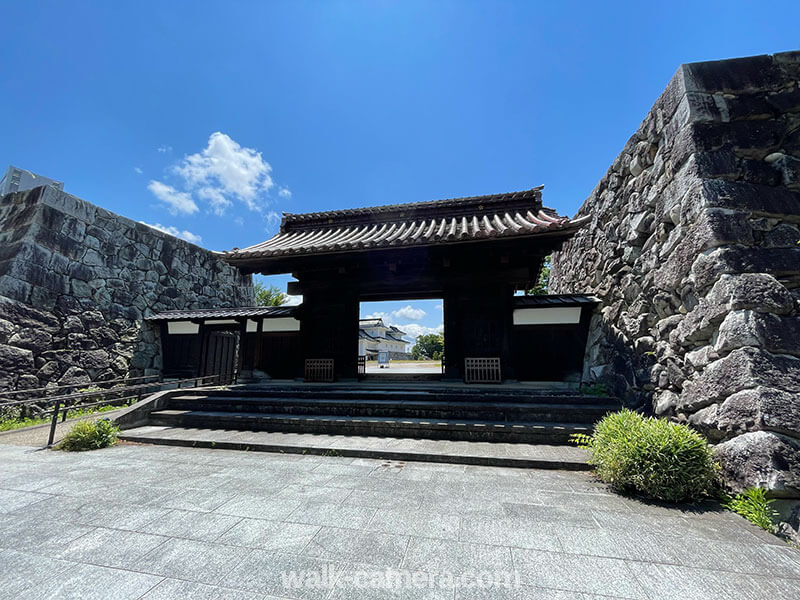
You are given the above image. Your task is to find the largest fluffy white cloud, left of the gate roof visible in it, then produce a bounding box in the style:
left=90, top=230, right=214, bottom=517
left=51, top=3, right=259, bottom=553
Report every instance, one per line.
left=174, top=131, right=275, bottom=214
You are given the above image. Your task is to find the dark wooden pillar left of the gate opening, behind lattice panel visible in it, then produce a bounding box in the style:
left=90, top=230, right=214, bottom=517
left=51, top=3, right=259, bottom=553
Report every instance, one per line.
left=300, top=285, right=358, bottom=380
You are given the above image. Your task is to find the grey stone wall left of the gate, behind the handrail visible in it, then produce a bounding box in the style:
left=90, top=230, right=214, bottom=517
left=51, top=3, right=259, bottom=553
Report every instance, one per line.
left=0, top=187, right=254, bottom=390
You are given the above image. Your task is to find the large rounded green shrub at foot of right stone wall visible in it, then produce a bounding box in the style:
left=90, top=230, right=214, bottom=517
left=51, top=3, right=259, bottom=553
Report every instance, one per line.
left=573, top=409, right=719, bottom=502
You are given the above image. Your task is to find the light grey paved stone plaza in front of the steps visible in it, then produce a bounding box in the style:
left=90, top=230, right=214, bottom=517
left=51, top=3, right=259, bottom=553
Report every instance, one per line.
left=0, top=445, right=800, bottom=600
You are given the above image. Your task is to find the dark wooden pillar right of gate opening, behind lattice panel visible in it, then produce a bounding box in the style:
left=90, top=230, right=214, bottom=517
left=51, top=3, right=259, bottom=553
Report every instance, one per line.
left=444, top=284, right=516, bottom=380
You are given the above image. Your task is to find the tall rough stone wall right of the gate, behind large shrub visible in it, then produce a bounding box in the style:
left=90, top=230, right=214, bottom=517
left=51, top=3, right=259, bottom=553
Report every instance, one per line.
left=552, top=52, right=800, bottom=529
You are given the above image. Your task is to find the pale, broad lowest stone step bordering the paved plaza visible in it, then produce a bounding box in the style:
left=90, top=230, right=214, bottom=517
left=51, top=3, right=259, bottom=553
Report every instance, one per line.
left=121, top=425, right=589, bottom=471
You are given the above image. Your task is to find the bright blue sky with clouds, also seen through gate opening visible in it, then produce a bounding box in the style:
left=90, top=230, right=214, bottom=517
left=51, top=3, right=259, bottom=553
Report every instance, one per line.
left=0, top=0, right=800, bottom=342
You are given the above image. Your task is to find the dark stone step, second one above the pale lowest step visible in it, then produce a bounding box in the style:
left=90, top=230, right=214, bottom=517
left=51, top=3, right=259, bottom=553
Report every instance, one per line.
left=161, top=396, right=619, bottom=424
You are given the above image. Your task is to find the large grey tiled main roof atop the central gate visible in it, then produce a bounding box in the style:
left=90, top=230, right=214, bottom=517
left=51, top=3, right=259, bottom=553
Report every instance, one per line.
left=225, top=188, right=590, bottom=263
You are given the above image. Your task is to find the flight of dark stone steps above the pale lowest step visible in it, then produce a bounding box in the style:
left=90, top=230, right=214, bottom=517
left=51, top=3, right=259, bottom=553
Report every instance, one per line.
left=123, top=383, right=620, bottom=445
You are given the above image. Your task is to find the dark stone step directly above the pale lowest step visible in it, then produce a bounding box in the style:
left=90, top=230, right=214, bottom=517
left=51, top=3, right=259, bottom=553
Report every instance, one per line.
left=150, top=409, right=592, bottom=444
